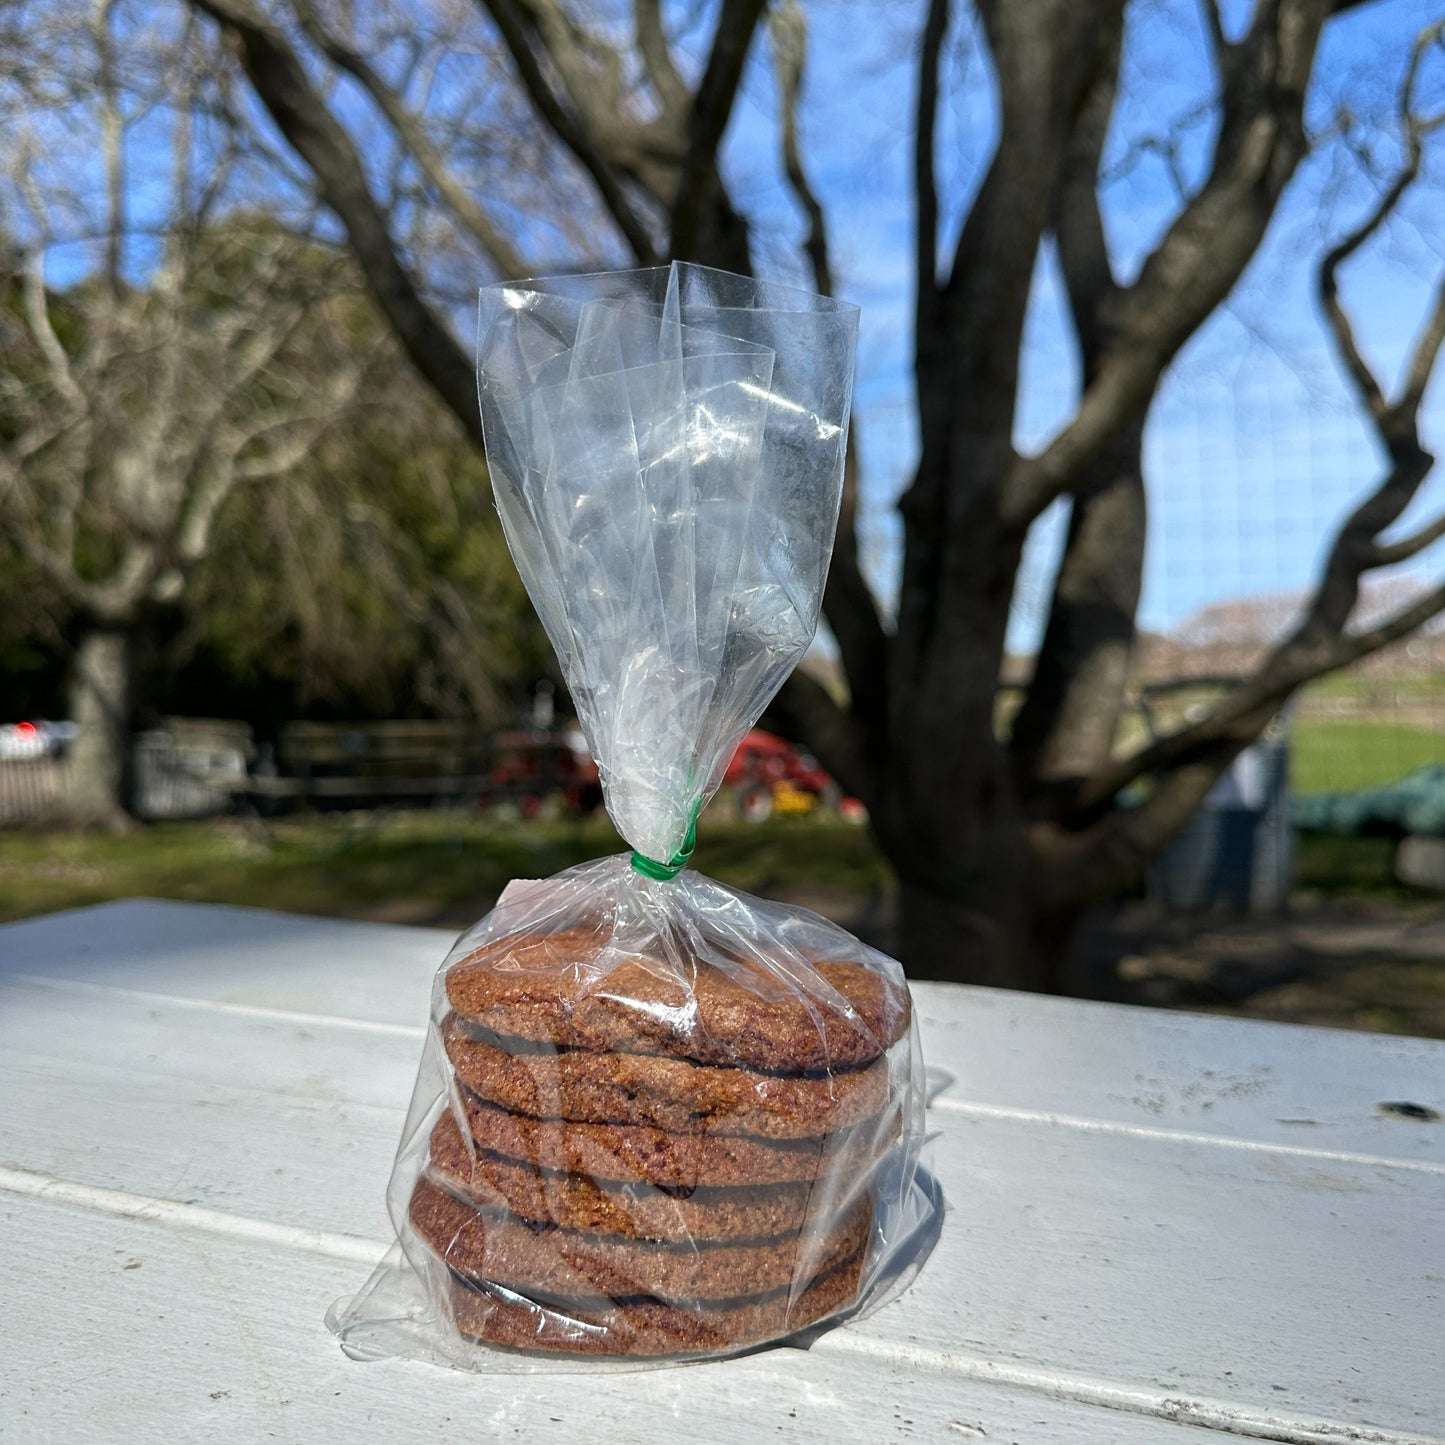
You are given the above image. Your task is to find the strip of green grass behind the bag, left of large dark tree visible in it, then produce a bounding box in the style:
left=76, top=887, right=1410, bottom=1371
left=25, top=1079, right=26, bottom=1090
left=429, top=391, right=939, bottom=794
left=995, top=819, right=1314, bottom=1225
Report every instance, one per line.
left=0, top=812, right=887, bottom=922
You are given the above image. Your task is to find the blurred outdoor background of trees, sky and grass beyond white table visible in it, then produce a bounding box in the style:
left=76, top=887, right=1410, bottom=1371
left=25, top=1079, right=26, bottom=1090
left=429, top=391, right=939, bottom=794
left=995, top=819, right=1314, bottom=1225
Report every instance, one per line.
left=0, top=0, right=1445, bottom=1036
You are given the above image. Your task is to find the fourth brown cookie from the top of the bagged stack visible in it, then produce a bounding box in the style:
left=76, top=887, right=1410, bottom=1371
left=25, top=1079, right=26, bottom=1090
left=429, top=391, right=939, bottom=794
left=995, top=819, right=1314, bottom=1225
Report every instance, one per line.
left=428, top=1114, right=826, bottom=1244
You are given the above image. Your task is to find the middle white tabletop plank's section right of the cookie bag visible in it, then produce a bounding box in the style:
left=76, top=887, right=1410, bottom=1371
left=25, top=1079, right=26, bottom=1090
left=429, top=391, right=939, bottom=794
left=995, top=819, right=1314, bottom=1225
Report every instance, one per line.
left=843, top=1116, right=1445, bottom=1439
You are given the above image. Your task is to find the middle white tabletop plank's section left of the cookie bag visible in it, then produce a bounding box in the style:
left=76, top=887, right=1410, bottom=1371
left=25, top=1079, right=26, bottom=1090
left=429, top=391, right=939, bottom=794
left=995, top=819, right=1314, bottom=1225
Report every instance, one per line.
left=0, top=981, right=407, bottom=1242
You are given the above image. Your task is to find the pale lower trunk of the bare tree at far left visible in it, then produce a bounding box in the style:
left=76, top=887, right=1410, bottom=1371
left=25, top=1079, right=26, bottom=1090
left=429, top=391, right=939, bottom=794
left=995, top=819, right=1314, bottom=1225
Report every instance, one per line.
left=65, top=627, right=131, bottom=828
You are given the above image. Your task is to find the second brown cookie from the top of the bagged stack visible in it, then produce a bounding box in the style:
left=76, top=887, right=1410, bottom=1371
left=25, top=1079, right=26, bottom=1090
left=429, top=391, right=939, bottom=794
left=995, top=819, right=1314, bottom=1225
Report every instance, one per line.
left=441, top=1014, right=889, bottom=1139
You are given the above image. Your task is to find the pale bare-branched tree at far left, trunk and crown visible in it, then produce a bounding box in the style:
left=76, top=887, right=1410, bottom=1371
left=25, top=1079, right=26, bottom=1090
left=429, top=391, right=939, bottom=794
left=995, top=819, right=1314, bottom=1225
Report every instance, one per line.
left=0, top=0, right=381, bottom=827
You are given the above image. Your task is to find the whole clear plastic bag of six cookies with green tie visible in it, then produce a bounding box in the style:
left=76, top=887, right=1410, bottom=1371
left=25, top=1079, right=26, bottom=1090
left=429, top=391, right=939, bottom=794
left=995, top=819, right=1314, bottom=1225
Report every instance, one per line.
left=328, top=264, right=939, bottom=1370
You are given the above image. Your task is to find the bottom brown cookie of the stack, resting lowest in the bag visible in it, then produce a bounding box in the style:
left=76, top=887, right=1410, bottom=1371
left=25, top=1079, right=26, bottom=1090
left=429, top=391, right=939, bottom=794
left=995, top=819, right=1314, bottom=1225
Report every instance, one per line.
left=451, top=1253, right=863, bottom=1355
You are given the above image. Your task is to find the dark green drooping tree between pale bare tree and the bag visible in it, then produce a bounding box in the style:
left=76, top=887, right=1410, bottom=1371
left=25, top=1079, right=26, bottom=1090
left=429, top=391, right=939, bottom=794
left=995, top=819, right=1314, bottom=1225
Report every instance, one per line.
left=170, top=359, right=556, bottom=731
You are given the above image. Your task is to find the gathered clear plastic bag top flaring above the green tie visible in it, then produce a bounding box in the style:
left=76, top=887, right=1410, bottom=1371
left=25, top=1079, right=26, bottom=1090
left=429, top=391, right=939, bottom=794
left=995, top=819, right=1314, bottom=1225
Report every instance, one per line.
left=478, top=264, right=857, bottom=881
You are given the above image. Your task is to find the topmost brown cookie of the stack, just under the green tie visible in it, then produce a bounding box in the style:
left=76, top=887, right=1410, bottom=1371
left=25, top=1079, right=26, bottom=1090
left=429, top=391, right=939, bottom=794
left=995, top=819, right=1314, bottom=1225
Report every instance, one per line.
left=445, top=928, right=909, bottom=1074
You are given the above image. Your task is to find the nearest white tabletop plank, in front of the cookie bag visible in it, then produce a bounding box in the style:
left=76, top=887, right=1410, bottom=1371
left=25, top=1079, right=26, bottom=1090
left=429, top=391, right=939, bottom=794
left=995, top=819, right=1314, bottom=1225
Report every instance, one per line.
left=0, top=1192, right=1254, bottom=1445
